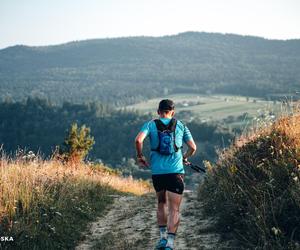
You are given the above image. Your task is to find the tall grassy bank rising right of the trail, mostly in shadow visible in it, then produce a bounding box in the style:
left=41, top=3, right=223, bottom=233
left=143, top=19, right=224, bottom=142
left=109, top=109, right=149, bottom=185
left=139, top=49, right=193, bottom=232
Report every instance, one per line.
left=199, top=114, right=300, bottom=249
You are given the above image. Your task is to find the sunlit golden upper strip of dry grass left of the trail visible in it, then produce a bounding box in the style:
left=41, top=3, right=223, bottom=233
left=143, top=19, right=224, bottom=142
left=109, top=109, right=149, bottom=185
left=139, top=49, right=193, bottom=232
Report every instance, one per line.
left=0, top=158, right=150, bottom=222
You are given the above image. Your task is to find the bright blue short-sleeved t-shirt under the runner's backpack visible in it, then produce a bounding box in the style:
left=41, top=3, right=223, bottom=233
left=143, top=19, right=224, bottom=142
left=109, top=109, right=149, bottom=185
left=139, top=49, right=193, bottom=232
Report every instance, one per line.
left=141, top=118, right=193, bottom=175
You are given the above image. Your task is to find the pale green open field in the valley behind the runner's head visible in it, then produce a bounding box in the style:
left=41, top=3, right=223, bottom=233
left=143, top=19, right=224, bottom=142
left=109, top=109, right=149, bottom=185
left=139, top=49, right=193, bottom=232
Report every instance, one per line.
left=126, top=94, right=282, bottom=129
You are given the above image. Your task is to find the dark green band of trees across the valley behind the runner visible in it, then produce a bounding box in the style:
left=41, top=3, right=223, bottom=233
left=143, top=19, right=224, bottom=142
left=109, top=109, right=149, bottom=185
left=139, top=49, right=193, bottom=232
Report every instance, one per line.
left=0, top=98, right=233, bottom=170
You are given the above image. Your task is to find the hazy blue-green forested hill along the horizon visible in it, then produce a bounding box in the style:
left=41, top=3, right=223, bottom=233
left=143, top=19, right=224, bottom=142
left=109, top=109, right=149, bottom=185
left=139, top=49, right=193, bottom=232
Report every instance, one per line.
left=0, top=32, right=300, bottom=105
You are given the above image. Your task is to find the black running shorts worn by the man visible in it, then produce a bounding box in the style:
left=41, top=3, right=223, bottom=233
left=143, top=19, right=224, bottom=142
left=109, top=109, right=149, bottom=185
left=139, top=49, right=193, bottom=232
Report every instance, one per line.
left=152, top=174, right=184, bottom=194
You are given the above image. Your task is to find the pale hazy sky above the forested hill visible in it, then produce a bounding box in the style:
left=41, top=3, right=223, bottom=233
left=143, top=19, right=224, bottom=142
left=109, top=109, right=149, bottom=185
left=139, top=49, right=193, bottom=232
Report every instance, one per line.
left=0, top=0, right=300, bottom=48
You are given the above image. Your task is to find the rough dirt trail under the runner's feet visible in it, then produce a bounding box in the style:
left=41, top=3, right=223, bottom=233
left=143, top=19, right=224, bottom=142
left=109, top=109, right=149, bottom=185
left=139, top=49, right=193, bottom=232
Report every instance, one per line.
left=76, top=192, right=220, bottom=250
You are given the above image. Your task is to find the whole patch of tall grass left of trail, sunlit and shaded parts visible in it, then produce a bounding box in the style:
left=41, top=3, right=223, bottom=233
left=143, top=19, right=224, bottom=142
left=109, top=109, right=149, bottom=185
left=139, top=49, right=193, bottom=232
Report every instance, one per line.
left=0, top=156, right=149, bottom=249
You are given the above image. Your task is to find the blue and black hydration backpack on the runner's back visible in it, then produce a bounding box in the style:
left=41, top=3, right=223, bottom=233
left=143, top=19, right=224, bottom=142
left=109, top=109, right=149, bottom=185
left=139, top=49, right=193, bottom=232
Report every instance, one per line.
left=154, top=118, right=178, bottom=155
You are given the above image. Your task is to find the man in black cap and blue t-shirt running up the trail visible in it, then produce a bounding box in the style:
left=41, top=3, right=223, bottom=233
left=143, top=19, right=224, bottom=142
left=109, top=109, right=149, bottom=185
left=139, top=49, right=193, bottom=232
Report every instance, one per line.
left=135, top=99, right=196, bottom=250
